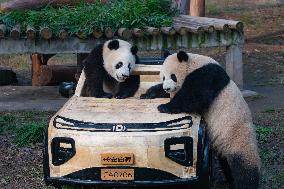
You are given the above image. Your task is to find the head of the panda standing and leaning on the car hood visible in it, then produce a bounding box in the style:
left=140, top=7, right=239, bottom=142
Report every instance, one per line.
left=160, top=51, right=189, bottom=93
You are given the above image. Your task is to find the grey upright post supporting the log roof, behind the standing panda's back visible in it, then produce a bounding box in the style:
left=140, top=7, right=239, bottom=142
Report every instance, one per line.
left=226, top=45, right=243, bottom=89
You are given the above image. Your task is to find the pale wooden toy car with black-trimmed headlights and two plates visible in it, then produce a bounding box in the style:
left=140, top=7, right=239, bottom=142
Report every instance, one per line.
left=44, top=59, right=210, bottom=188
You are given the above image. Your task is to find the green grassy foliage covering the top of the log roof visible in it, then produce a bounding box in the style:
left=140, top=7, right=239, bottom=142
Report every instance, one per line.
left=0, top=0, right=177, bottom=35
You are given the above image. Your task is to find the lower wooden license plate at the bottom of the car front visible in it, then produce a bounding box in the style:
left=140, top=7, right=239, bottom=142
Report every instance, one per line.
left=101, top=169, right=134, bottom=181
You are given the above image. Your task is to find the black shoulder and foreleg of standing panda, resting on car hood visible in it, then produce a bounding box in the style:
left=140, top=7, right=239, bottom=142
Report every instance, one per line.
left=159, top=64, right=230, bottom=115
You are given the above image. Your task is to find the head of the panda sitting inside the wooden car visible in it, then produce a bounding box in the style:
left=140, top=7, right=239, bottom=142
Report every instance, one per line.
left=103, top=39, right=138, bottom=82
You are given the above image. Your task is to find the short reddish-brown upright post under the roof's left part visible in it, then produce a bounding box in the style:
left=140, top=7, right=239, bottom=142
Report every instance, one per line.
left=31, top=54, right=43, bottom=86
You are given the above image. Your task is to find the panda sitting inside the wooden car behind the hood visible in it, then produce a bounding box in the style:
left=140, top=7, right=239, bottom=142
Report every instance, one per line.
left=83, top=39, right=140, bottom=98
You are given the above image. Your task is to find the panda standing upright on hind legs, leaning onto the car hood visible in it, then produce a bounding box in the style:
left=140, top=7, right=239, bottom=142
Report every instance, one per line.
left=142, top=51, right=260, bottom=189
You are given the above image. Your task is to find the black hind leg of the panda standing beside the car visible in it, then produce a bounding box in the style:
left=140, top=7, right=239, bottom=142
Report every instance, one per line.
left=219, top=155, right=260, bottom=189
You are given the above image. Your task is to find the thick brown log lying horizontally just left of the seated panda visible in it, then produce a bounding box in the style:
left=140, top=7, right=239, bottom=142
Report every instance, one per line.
left=39, top=65, right=77, bottom=86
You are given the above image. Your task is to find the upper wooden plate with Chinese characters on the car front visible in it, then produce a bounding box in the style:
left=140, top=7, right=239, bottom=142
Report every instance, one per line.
left=101, top=153, right=134, bottom=165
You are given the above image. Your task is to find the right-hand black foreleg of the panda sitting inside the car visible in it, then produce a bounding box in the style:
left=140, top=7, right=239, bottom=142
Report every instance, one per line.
left=115, top=75, right=140, bottom=99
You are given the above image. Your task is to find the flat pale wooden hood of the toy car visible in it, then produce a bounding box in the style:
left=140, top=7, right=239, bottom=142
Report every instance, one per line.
left=59, top=97, right=191, bottom=123
